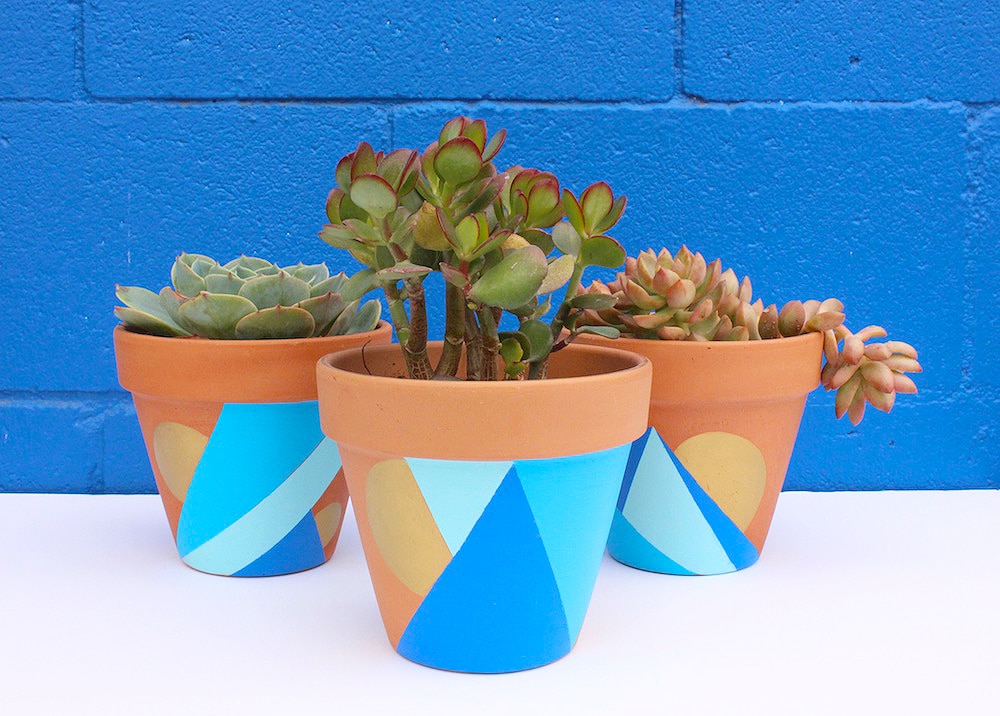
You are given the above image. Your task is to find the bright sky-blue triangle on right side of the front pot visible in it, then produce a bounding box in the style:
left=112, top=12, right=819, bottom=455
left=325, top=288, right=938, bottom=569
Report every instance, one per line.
left=514, top=445, right=630, bottom=643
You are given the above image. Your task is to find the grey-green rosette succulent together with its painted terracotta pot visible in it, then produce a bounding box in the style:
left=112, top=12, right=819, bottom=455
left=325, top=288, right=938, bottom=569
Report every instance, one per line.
left=114, top=253, right=391, bottom=576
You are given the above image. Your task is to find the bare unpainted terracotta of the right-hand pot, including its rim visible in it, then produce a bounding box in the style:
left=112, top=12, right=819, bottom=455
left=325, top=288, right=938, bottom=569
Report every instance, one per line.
left=578, top=333, right=823, bottom=550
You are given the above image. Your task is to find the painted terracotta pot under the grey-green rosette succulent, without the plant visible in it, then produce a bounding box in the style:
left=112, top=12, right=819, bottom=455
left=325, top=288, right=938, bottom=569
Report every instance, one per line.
left=114, top=322, right=392, bottom=577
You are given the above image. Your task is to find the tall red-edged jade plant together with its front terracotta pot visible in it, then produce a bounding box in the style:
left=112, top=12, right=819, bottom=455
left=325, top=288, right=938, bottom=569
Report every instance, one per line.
left=317, top=117, right=651, bottom=672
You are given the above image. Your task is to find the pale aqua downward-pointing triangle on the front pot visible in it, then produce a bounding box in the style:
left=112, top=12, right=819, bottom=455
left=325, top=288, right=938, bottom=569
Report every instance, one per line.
left=406, top=457, right=514, bottom=554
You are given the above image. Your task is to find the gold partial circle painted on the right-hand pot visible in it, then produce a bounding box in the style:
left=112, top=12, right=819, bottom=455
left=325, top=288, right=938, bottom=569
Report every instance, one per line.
left=674, top=432, right=767, bottom=531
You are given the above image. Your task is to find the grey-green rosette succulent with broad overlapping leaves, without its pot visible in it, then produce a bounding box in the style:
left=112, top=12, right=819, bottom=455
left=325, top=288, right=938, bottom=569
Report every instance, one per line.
left=115, top=253, right=381, bottom=340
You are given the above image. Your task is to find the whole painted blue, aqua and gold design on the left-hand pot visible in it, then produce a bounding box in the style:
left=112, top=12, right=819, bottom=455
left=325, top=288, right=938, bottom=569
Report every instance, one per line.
left=152, top=401, right=347, bottom=577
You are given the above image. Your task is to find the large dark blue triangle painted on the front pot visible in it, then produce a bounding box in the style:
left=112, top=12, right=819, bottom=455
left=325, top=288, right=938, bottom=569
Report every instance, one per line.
left=396, top=468, right=571, bottom=673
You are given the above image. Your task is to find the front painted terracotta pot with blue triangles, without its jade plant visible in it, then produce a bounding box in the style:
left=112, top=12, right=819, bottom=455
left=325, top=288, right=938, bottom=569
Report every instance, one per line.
left=317, top=345, right=651, bottom=673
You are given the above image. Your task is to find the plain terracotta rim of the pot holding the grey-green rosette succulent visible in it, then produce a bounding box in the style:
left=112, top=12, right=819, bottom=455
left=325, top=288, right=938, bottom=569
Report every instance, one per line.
left=114, top=321, right=392, bottom=403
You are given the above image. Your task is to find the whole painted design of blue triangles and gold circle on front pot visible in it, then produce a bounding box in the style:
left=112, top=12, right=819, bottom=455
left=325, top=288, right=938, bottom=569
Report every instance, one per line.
left=364, top=445, right=629, bottom=673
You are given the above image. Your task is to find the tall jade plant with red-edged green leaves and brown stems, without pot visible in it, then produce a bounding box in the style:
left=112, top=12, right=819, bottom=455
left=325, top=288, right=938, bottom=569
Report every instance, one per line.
left=320, top=117, right=626, bottom=380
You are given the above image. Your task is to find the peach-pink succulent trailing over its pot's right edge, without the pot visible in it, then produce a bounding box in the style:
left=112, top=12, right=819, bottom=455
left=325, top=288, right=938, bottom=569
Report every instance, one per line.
left=578, top=246, right=921, bottom=425
